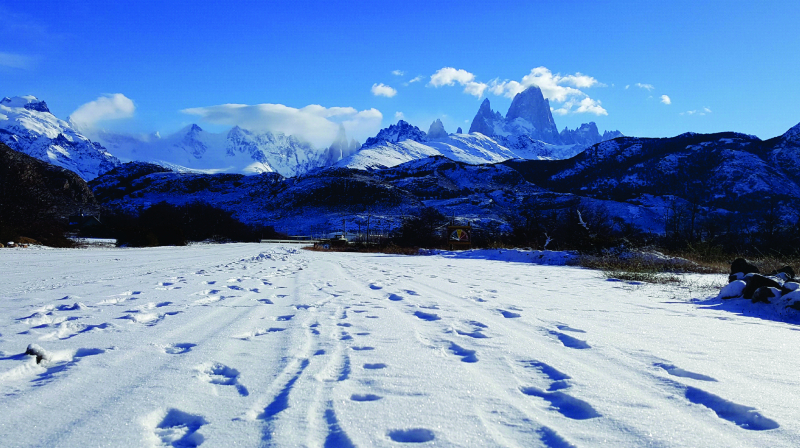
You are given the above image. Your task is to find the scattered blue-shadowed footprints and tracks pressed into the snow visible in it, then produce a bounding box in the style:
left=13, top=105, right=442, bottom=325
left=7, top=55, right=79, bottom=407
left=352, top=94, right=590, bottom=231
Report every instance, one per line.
left=7, top=252, right=779, bottom=447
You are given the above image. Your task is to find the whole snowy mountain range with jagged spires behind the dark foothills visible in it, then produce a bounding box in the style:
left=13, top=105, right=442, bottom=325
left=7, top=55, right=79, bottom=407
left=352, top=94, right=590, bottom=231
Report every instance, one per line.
left=0, top=86, right=622, bottom=180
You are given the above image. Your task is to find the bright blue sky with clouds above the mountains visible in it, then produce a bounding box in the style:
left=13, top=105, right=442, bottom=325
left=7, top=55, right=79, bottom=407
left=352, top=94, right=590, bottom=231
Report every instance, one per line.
left=0, top=0, right=800, bottom=145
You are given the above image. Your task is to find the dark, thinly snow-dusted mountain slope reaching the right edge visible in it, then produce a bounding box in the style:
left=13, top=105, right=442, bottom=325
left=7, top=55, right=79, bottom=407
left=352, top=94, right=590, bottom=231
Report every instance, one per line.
left=504, top=127, right=800, bottom=211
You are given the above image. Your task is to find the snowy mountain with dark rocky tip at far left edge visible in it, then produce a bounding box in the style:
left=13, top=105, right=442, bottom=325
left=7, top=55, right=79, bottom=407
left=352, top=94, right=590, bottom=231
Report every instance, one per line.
left=0, top=95, right=120, bottom=180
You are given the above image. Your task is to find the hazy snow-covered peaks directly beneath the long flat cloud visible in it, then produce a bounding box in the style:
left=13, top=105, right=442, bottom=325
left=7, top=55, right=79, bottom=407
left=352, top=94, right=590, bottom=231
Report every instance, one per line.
left=98, top=124, right=326, bottom=177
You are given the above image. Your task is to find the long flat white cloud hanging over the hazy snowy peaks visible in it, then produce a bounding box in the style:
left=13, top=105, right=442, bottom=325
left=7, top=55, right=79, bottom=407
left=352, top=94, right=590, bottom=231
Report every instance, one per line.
left=181, top=103, right=383, bottom=147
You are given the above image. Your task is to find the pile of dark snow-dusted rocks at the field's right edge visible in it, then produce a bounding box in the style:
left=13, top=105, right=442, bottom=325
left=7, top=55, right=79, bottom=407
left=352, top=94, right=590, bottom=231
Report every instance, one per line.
left=717, top=258, right=800, bottom=311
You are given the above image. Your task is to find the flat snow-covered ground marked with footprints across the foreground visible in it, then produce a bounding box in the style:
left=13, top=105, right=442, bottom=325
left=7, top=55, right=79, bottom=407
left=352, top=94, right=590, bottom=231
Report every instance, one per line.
left=0, top=244, right=800, bottom=448
